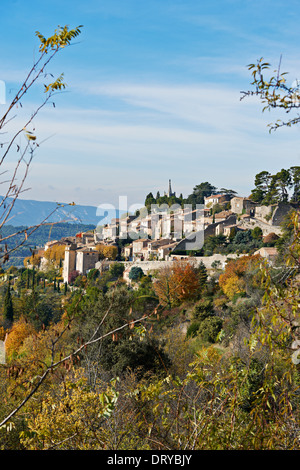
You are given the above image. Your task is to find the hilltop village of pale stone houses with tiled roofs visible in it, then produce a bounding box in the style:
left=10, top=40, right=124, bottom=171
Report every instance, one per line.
left=24, top=181, right=293, bottom=284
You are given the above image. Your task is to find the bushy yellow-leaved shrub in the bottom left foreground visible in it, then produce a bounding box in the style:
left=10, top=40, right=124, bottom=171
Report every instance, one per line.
left=17, top=370, right=119, bottom=450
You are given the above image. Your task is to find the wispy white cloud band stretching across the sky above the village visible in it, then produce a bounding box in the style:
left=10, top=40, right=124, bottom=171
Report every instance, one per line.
left=2, top=83, right=299, bottom=205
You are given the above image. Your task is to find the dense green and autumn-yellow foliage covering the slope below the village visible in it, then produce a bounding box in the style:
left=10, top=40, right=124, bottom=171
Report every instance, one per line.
left=0, top=209, right=300, bottom=450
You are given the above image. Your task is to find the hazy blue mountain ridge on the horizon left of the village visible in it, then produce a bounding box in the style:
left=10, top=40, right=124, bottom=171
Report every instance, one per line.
left=0, top=196, right=116, bottom=227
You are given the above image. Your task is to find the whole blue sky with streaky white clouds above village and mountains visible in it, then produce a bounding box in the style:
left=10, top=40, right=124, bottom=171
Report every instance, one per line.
left=0, top=0, right=300, bottom=206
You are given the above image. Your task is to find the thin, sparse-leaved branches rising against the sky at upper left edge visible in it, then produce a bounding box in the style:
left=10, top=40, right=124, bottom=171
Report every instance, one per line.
left=0, top=26, right=82, bottom=263
